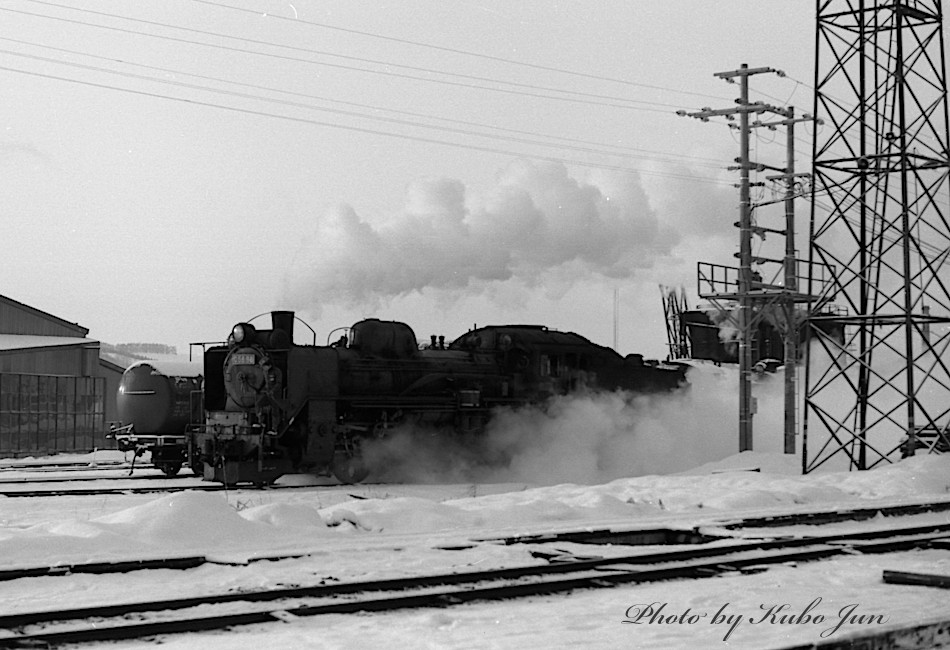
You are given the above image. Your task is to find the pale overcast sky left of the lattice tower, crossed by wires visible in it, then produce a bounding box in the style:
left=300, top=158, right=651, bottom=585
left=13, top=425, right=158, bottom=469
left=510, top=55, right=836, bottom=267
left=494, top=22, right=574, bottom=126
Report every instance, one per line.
left=0, top=0, right=815, bottom=357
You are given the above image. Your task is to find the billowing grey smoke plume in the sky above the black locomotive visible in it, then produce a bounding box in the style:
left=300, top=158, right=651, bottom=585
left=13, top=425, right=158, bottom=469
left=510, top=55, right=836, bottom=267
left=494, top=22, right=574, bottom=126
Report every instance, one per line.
left=286, top=162, right=678, bottom=308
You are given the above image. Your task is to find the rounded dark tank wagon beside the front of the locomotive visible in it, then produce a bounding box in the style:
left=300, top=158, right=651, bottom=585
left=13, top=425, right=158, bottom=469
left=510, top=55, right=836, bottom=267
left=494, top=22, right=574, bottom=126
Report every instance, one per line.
left=109, top=361, right=204, bottom=476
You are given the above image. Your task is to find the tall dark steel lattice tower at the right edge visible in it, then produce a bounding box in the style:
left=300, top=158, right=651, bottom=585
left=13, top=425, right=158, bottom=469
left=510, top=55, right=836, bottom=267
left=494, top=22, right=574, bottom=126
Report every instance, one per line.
left=802, top=0, right=950, bottom=472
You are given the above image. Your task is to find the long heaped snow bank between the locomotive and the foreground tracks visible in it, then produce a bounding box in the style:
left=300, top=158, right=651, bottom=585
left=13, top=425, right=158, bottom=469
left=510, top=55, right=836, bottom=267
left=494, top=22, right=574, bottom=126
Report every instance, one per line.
left=0, top=454, right=950, bottom=567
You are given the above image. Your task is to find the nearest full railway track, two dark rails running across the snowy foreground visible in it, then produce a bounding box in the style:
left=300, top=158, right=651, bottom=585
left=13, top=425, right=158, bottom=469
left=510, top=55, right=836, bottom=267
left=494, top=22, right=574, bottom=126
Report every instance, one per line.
left=0, top=512, right=950, bottom=648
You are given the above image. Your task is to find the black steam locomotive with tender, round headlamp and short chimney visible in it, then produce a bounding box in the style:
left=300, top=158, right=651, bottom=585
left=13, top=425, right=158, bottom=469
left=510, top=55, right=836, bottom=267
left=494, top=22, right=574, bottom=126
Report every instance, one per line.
left=190, top=311, right=685, bottom=484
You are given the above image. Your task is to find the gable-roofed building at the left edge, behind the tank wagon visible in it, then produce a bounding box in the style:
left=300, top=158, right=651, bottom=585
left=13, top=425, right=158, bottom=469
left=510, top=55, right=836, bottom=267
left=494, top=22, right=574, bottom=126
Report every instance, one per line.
left=0, top=296, right=123, bottom=458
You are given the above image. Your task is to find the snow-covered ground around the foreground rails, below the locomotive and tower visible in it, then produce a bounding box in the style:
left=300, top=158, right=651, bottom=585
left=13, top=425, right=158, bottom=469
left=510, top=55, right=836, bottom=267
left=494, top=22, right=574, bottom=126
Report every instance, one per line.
left=0, top=452, right=950, bottom=649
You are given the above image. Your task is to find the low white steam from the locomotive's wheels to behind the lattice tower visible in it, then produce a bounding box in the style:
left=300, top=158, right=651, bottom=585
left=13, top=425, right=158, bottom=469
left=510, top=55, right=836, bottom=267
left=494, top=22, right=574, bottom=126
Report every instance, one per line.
left=364, top=332, right=947, bottom=485
